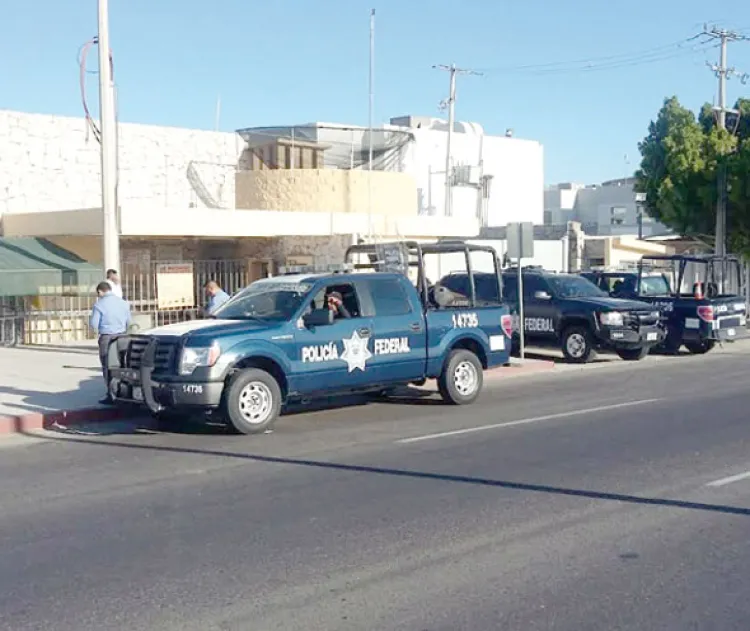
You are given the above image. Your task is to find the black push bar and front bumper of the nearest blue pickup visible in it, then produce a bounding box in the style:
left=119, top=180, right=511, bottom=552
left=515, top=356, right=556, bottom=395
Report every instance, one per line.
left=109, top=341, right=224, bottom=414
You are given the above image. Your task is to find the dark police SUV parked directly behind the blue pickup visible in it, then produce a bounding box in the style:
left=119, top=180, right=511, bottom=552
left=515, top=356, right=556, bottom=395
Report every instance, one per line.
left=439, top=267, right=665, bottom=364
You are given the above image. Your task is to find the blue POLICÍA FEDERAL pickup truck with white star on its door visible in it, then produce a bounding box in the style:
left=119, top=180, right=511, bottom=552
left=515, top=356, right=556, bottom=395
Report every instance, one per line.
left=109, top=246, right=512, bottom=434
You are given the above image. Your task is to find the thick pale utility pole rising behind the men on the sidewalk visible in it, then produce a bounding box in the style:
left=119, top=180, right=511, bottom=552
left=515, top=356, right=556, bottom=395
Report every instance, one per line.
left=98, top=0, right=120, bottom=270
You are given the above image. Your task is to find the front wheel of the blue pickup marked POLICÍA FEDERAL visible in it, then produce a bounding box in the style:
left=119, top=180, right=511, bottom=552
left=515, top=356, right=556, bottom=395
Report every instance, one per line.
left=224, top=368, right=282, bottom=434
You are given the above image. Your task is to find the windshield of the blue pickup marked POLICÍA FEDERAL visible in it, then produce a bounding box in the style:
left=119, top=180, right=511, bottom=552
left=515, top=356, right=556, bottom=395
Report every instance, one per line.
left=214, top=280, right=312, bottom=322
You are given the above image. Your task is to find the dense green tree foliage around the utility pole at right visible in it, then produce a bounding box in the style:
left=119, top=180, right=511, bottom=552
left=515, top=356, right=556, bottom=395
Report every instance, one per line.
left=636, top=97, right=750, bottom=254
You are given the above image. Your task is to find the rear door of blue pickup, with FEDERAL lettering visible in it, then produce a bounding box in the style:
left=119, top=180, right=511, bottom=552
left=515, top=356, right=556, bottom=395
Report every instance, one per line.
left=358, top=276, right=427, bottom=383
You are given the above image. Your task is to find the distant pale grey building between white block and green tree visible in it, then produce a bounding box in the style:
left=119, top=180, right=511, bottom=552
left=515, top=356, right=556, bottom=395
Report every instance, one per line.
left=544, top=178, right=668, bottom=237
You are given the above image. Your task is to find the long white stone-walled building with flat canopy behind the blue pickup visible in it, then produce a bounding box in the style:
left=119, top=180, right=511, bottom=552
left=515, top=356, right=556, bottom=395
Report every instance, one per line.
left=0, top=111, right=543, bottom=342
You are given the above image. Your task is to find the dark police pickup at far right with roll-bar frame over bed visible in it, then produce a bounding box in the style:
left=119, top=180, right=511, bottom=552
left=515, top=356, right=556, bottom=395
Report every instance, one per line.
left=581, top=255, right=748, bottom=354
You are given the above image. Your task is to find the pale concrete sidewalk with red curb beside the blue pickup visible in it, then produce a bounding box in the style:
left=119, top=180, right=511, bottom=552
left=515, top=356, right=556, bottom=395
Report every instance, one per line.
left=0, top=342, right=554, bottom=434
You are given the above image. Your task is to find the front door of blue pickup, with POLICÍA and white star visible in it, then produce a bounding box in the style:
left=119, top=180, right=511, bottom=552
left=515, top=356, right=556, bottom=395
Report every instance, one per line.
left=292, top=282, right=373, bottom=394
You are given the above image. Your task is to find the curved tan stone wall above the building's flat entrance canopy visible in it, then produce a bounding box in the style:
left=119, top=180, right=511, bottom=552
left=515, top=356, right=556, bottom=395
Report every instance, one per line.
left=236, top=169, right=418, bottom=216
